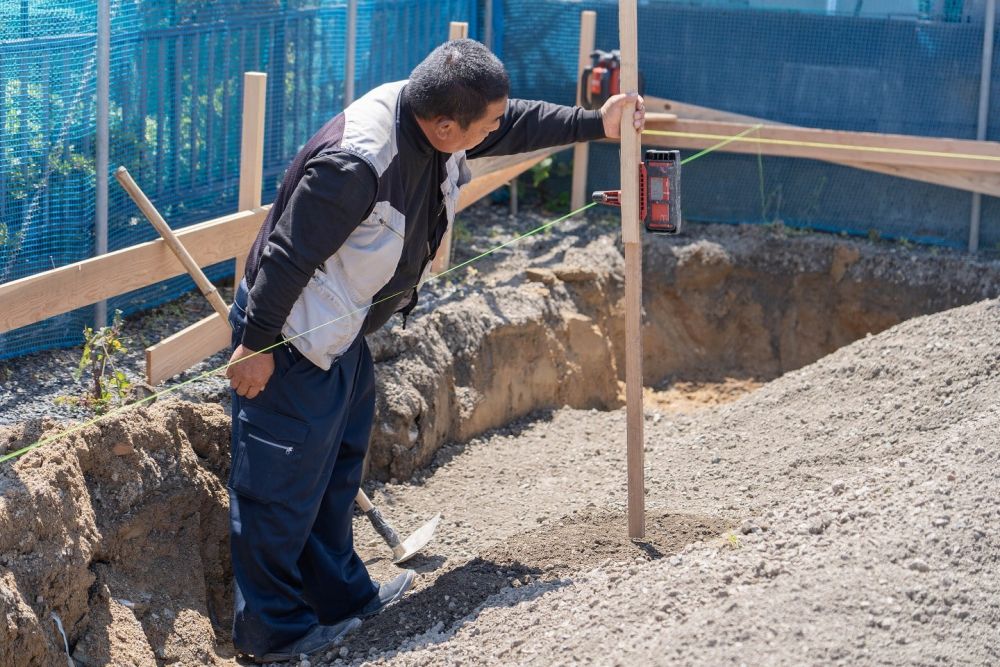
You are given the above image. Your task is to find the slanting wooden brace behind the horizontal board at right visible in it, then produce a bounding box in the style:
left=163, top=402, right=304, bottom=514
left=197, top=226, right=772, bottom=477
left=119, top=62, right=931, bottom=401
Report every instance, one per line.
left=646, top=97, right=1000, bottom=197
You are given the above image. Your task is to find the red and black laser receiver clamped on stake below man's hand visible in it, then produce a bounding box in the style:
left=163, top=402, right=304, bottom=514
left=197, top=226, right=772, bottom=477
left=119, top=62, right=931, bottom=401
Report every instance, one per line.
left=592, top=149, right=681, bottom=234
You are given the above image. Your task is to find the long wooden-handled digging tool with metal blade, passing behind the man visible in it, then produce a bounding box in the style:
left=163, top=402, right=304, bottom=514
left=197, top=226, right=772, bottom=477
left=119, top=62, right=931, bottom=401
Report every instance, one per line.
left=115, top=167, right=441, bottom=565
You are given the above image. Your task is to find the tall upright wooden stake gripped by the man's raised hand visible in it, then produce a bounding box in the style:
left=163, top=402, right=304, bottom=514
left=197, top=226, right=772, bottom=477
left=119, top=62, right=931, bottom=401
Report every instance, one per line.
left=618, top=0, right=646, bottom=539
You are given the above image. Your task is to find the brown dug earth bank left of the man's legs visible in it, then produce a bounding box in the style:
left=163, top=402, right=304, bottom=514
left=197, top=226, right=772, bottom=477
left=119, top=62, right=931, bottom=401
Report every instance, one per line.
left=0, top=402, right=232, bottom=666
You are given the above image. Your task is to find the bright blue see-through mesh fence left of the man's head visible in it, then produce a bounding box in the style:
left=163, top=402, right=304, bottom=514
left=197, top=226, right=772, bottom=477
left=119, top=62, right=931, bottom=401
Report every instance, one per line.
left=0, top=0, right=479, bottom=359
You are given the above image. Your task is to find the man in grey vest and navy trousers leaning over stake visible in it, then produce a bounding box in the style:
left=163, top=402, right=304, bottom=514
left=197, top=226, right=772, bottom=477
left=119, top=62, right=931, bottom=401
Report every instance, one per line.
left=227, top=40, right=644, bottom=662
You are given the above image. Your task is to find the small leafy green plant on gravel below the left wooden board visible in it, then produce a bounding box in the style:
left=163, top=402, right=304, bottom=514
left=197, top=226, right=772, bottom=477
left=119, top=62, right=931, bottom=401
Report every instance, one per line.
left=64, top=310, right=132, bottom=414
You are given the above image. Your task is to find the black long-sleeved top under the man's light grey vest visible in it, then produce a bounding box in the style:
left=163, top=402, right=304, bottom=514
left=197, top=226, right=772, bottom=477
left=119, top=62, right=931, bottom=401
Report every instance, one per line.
left=243, top=94, right=605, bottom=350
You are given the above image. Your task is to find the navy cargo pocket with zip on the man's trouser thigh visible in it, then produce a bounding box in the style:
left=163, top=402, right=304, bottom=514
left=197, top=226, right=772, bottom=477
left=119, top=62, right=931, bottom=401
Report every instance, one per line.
left=229, top=405, right=309, bottom=503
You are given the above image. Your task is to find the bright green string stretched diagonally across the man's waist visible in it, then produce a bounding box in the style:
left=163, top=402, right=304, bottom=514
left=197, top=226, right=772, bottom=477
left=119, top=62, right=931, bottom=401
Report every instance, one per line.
left=0, top=124, right=762, bottom=463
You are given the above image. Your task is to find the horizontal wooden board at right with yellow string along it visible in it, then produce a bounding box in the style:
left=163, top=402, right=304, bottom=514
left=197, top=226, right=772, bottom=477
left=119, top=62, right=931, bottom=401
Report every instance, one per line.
left=643, top=118, right=1000, bottom=173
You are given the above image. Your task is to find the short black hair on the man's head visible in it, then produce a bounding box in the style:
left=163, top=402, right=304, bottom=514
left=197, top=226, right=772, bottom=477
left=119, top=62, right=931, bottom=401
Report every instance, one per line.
left=406, top=39, right=510, bottom=130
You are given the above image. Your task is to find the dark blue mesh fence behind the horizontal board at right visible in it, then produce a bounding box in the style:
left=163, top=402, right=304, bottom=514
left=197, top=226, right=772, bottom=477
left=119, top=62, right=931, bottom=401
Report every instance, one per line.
left=497, top=0, right=1000, bottom=248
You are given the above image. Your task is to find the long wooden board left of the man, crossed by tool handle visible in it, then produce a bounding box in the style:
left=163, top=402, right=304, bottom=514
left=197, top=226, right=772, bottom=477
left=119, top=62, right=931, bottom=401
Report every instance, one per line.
left=0, top=207, right=269, bottom=332
